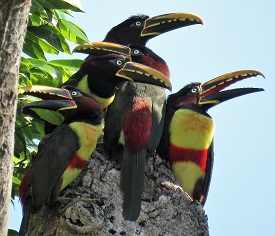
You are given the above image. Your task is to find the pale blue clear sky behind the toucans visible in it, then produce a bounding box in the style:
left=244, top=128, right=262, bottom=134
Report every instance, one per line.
left=10, top=0, right=275, bottom=236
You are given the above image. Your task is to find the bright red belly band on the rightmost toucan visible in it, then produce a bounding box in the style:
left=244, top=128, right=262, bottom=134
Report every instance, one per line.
left=169, top=144, right=208, bottom=171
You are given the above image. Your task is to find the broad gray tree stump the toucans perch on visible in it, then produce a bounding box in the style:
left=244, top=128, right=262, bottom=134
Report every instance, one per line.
left=28, top=145, right=209, bottom=236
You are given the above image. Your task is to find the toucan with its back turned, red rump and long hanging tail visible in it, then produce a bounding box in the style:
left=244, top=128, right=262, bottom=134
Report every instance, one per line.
left=74, top=42, right=170, bottom=221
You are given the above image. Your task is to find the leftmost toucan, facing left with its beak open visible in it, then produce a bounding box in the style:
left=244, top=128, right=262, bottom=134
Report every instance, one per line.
left=18, top=85, right=104, bottom=235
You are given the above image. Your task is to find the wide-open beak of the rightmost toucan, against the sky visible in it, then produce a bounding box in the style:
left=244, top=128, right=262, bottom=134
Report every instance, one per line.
left=198, top=70, right=264, bottom=108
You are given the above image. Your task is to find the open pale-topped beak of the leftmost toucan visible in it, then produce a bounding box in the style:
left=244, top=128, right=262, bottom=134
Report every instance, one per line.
left=18, top=85, right=77, bottom=114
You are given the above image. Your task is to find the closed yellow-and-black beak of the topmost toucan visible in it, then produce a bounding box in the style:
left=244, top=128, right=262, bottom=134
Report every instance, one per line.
left=140, top=12, right=203, bottom=37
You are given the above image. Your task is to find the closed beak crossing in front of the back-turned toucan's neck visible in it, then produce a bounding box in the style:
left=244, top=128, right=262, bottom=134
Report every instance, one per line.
left=116, top=62, right=172, bottom=91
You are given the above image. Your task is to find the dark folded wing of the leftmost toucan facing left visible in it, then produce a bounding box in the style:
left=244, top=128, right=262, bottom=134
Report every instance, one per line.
left=29, top=124, right=79, bottom=211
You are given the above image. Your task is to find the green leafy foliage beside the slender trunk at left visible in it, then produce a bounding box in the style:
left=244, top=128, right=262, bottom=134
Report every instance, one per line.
left=12, top=0, right=88, bottom=206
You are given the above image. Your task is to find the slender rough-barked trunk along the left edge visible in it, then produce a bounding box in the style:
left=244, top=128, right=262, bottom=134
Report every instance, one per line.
left=0, top=0, right=31, bottom=235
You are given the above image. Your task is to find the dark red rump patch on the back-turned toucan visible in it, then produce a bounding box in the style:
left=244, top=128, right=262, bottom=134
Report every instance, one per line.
left=122, top=98, right=152, bottom=152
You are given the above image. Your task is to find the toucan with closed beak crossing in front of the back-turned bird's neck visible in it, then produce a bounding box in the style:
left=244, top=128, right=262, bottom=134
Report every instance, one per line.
left=61, top=45, right=171, bottom=109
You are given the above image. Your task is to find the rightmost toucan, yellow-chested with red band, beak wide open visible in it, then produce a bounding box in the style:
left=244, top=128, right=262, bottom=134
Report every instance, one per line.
left=157, top=70, right=264, bottom=205
